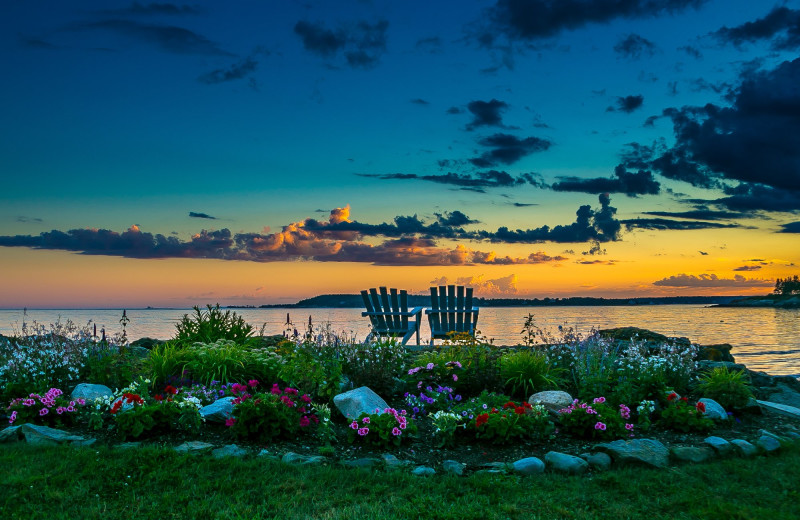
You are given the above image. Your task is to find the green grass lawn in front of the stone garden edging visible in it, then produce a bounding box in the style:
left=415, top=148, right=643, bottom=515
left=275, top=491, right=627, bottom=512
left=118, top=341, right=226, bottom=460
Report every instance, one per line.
left=0, top=444, right=800, bottom=520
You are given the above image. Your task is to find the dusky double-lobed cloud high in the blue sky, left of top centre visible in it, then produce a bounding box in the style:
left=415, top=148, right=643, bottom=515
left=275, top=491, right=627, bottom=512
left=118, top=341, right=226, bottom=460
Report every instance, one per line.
left=294, top=20, right=389, bottom=69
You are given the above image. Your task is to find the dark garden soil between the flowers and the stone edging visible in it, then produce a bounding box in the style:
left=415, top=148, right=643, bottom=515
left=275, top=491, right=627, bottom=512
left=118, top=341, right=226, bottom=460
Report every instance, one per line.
left=62, top=396, right=800, bottom=472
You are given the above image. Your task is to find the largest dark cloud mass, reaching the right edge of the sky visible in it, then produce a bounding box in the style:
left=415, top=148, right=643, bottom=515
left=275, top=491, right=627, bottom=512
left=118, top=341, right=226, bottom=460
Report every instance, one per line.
left=652, top=58, right=800, bottom=195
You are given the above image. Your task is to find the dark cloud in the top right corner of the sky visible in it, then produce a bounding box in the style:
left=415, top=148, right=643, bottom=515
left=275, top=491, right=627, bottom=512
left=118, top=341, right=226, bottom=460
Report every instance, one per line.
left=711, top=6, right=800, bottom=50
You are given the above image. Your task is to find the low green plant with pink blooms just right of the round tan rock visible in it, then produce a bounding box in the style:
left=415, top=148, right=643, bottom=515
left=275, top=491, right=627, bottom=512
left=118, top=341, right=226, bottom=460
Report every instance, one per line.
left=559, top=397, right=634, bottom=440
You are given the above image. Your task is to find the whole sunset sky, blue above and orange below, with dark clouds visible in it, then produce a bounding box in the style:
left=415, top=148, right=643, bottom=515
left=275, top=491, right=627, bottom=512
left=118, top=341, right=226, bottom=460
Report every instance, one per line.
left=0, top=0, right=800, bottom=308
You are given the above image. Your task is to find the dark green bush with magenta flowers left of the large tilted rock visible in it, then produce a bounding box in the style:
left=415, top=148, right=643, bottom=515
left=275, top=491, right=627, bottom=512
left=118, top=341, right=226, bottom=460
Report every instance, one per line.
left=227, top=385, right=319, bottom=442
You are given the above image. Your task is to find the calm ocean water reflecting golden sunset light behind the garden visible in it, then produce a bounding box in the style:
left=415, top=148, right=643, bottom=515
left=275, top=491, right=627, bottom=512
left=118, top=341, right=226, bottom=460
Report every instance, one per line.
left=0, top=305, right=800, bottom=377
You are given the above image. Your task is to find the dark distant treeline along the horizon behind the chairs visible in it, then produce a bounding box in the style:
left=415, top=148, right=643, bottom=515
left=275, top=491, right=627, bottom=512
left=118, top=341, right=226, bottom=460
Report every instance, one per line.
left=229, top=294, right=742, bottom=309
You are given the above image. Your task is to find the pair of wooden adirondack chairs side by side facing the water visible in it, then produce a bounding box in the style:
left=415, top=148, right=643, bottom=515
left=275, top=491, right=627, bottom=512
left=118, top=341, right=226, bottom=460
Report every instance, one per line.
left=361, top=285, right=478, bottom=345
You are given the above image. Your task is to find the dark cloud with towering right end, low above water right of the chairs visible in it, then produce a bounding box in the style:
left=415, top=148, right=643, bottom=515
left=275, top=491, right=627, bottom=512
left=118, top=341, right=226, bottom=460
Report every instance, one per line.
left=476, top=195, right=621, bottom=244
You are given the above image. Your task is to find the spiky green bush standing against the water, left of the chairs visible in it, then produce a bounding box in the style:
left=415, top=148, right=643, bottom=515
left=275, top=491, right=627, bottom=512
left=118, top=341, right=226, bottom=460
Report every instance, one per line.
left=174, top=304, right=255, bottom=344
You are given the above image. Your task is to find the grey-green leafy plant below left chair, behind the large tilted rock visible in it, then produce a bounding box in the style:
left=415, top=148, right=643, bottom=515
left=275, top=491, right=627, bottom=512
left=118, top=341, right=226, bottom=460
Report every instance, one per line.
left=339, top=339, right=406, bottom=395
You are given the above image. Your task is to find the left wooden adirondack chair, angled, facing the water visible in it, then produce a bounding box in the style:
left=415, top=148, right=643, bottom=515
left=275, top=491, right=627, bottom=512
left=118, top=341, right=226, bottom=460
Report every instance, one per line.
left=361, top=287, right=422, bottom=345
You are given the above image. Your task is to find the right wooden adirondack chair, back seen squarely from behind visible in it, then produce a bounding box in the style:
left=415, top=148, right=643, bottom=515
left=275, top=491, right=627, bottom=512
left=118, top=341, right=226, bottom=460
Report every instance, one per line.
left=425, top=285, right=478, bottom=345
